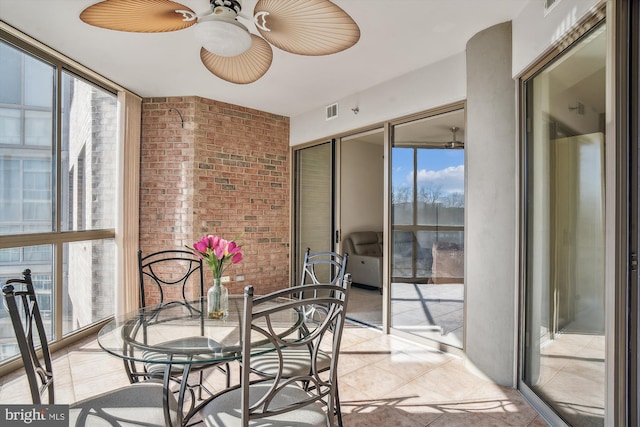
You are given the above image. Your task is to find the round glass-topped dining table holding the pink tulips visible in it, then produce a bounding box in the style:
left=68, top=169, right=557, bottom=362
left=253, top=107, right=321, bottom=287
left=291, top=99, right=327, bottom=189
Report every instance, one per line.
left=98, top=295, right=303, bottom=427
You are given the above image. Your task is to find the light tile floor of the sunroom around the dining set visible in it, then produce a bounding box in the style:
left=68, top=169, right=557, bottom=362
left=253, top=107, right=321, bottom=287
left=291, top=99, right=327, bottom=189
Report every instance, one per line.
left=0, top=324, right=547, bottom=427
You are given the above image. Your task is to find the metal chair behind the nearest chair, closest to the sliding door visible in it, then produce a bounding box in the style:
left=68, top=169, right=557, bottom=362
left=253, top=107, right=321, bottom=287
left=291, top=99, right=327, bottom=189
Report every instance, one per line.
left=251, top=248, right=351, bottom=426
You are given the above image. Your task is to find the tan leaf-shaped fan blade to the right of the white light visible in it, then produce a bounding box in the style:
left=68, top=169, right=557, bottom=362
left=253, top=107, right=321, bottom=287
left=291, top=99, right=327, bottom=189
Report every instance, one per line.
left=254, top=0, right=360, bottom=56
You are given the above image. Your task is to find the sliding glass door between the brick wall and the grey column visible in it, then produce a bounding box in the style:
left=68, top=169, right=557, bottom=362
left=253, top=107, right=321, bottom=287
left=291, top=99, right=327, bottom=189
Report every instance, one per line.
left=292, top=108, right=465, bottom=349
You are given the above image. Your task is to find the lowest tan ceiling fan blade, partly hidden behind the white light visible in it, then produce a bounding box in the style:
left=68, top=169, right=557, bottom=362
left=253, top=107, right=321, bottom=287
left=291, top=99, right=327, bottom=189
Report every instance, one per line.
left=200, top=34, right=273, bottom=84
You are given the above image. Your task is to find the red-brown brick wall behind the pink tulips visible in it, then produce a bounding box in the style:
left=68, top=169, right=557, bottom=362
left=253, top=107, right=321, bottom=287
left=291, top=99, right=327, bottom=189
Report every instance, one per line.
left=140, top=97, right=291, bottom=300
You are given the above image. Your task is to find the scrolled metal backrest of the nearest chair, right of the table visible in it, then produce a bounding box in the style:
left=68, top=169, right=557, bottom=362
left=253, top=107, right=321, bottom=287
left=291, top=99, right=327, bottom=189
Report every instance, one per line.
left=241, top=274, right=351, bottom=425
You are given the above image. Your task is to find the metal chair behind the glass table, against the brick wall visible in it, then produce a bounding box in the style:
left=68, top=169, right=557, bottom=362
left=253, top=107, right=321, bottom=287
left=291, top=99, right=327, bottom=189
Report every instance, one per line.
left=124, top=249, right=231, bottom=400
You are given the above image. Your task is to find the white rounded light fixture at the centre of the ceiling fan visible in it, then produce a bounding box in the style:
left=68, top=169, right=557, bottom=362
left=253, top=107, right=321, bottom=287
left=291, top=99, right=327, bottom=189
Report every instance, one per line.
left=194, top=7, right=251, bottom=56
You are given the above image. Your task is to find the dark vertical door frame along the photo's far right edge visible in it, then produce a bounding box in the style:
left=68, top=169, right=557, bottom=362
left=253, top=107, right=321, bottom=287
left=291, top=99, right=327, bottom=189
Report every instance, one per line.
left=608, top=0, right=640, bottom=426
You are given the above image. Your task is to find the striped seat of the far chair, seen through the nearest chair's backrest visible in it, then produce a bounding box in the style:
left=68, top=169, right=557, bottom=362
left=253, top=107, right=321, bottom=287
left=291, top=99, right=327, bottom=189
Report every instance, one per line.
left=251, top=347, right=331, bottom=378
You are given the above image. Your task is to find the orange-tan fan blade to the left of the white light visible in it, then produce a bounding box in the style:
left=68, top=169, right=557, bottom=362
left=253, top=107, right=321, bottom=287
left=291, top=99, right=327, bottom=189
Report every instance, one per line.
left=80, top=0, right=196, bottom=33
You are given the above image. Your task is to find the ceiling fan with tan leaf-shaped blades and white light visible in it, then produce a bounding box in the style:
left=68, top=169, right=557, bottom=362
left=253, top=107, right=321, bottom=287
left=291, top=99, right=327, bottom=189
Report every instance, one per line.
left=80, top=0, right=360, bottom=84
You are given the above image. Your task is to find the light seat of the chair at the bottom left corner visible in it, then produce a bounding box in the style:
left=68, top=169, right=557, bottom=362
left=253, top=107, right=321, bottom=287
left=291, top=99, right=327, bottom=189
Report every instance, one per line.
left=69, top=382, right=178, bottom=427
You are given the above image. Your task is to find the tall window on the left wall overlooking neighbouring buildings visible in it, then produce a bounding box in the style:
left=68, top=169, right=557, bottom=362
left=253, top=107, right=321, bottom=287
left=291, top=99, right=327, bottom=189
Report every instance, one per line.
left=0, top=36, right=118, bottom=362
